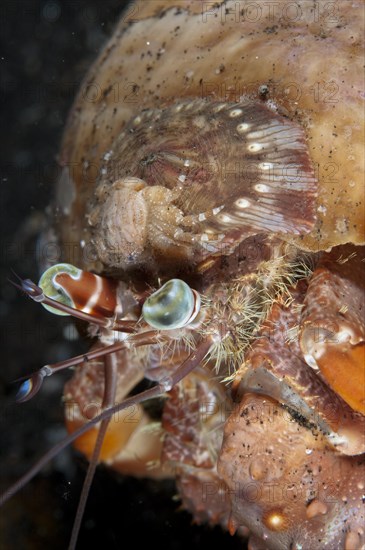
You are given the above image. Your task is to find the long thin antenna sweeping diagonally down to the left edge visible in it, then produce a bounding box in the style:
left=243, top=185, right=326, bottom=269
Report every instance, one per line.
left=0, top=336, right=214, bottom=506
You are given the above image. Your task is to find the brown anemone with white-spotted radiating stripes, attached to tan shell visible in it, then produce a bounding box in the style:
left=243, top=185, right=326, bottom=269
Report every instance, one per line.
left=88, top=99, right=317, bottom=269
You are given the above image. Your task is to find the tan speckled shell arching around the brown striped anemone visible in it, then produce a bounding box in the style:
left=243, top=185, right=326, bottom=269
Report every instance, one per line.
left=57, top=0, right=364, bottom=267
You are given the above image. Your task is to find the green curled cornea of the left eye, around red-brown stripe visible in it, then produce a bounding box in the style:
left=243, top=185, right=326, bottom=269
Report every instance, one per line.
left=38, top=264, right=82, bottom=315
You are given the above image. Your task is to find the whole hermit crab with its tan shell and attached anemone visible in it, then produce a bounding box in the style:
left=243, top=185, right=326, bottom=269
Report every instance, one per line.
left=0, top=0, right=365, bottom=550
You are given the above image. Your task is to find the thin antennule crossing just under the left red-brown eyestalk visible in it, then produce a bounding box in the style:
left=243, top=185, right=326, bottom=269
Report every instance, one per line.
left=9, top=272, right=136, bottom=333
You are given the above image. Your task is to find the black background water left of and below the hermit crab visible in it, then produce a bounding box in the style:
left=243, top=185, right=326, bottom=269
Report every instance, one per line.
left=0, top=0, right=244, bottom=550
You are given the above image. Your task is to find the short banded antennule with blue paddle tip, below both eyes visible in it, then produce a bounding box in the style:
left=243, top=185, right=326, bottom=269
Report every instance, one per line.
left=16, top=330, right=159, bottom=403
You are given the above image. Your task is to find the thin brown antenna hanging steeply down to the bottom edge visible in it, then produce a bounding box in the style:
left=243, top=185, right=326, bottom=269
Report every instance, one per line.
left=69, top=354, right=117, bottom=550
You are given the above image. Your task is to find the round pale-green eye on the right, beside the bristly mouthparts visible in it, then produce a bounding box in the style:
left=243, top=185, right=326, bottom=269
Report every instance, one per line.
left=142, top=279, right=200, bottom=330
